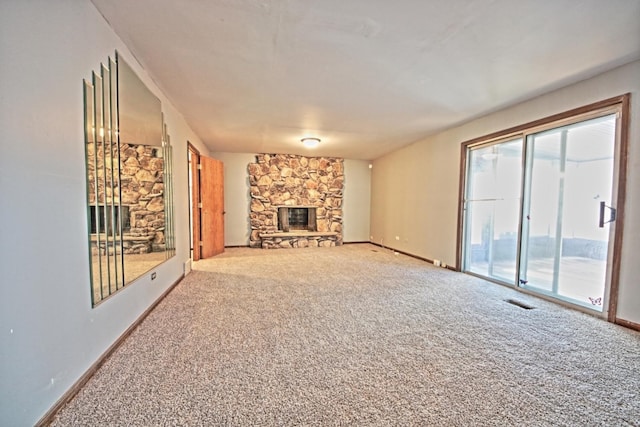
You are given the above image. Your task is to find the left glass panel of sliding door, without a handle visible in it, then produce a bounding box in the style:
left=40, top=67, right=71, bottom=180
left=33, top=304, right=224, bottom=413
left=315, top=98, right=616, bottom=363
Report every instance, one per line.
left=463, top=138, right=522, bottom=284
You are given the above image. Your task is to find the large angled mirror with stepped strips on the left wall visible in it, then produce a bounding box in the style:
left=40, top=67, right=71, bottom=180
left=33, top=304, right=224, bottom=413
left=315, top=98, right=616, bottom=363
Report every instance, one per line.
left=84, top=52, right=175, bottom=306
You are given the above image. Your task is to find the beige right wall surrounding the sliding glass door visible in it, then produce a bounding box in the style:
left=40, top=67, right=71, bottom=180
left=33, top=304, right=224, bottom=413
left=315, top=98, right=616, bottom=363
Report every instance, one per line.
left=371, top=61, right=640, bottom=323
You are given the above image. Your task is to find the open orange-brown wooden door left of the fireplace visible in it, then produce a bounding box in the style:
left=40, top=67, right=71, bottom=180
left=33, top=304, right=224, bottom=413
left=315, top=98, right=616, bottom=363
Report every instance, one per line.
left=200, top=155, right=224, bottom=258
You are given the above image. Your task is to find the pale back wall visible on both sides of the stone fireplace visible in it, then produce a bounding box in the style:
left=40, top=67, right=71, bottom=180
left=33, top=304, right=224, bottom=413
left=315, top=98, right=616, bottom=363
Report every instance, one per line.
left=211, top=152, right=371, bottom=246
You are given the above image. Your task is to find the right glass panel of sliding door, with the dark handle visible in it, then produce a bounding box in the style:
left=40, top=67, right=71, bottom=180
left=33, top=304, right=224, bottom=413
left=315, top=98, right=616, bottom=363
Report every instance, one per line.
left=519, top=115, right=616, bottom=311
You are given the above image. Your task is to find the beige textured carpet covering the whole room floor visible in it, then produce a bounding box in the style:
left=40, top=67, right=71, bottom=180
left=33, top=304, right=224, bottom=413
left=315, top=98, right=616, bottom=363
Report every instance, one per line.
left=53, top=244, right=640, bottom=426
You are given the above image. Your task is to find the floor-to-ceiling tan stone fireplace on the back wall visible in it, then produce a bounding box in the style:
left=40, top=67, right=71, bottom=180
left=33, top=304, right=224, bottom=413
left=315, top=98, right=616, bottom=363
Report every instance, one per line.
left=248, top=154, right=344, bottom=249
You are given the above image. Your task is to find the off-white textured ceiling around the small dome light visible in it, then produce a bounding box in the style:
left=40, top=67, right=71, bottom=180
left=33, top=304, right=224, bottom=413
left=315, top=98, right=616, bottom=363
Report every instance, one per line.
left=93, top=0, right=640, bottom=159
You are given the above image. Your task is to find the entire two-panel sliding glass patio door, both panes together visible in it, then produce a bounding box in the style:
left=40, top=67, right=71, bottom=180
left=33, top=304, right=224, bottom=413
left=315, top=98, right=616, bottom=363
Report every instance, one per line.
left=461, top=105, right=623, bottom=313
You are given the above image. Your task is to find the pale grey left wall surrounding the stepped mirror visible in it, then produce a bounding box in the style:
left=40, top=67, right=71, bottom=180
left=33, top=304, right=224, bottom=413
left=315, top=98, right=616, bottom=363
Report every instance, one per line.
left=0, top=0, right=202, bottom=426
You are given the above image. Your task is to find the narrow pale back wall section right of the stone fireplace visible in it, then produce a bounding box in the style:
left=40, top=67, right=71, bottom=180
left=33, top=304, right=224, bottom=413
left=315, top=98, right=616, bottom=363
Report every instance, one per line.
left=342, top=159, right=371, bottom=243
